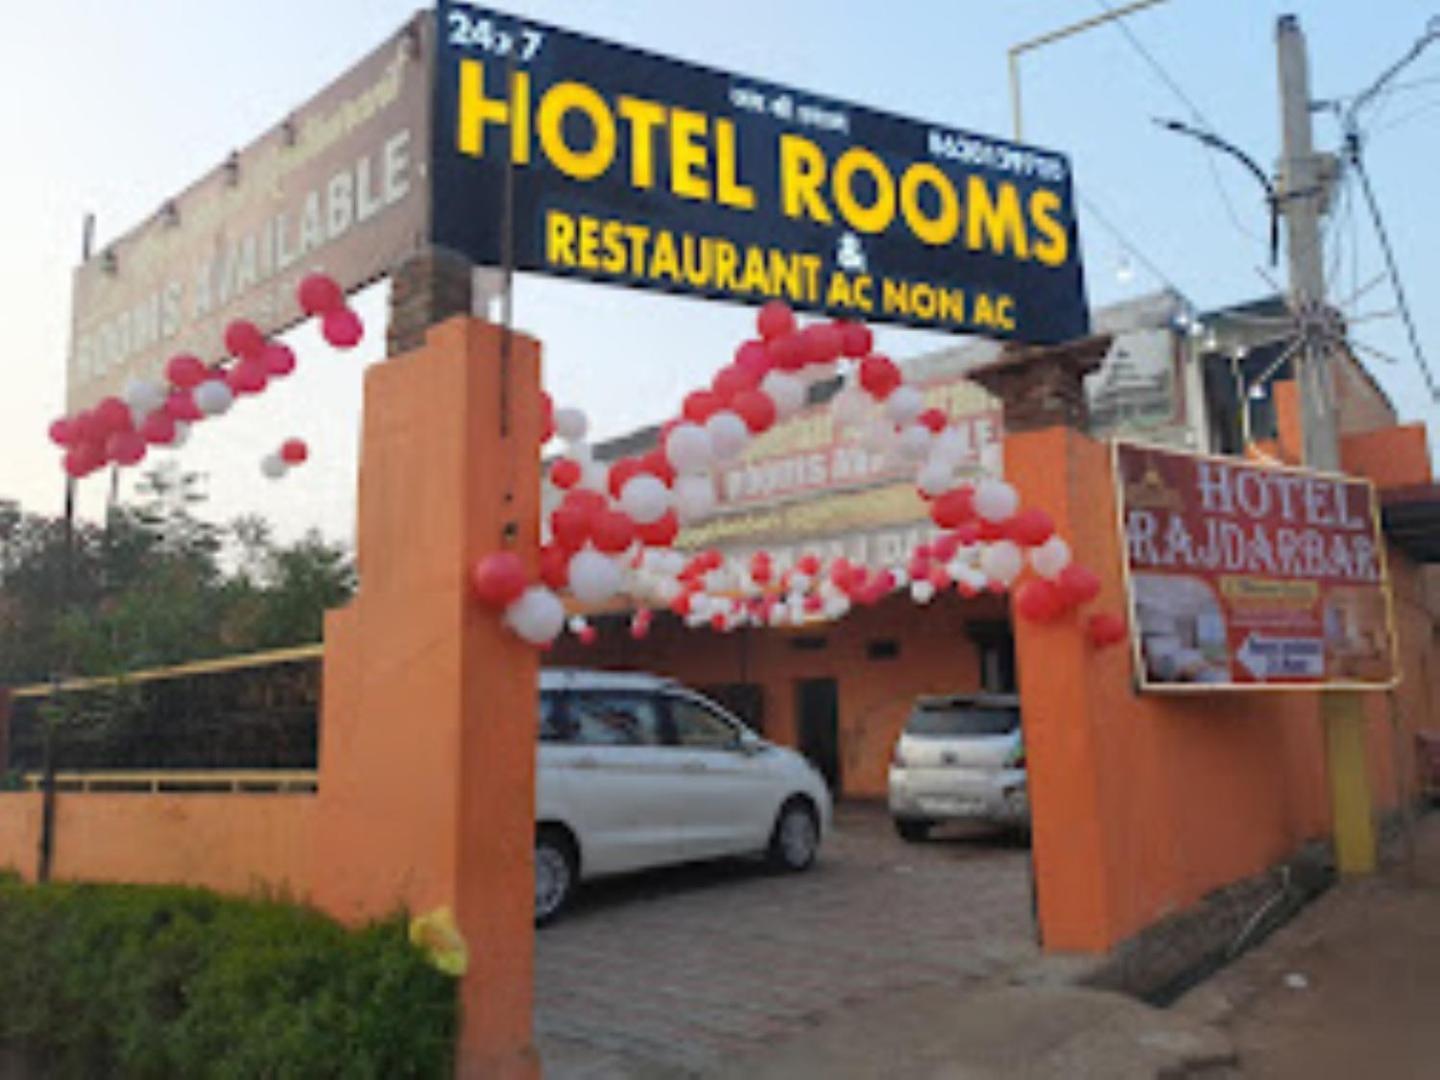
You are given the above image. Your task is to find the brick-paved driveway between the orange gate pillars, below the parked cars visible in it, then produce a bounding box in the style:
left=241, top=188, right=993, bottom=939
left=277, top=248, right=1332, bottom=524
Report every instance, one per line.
left=536, top=808, right=1038, bottom=1077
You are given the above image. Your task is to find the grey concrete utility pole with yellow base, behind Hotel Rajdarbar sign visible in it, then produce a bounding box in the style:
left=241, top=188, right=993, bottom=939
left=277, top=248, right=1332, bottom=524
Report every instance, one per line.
left=1274, top=14, right=1375, bottom=874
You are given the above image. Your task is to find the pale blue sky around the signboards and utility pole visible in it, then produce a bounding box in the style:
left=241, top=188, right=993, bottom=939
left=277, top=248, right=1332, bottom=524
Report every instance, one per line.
left=0, top=0, right=1440, bottom=539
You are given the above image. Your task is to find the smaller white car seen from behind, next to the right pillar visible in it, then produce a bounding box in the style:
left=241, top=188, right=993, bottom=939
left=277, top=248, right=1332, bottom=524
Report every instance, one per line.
left=890, top=694, right=1030, bottom=842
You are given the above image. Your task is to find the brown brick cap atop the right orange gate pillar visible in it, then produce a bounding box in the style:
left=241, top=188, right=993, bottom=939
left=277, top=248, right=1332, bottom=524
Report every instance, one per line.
left=969, top=334, right=1113, bottom=435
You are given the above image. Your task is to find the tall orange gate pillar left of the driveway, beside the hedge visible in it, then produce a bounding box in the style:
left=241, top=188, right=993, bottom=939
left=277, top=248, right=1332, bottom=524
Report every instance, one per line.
left=314, top=317, right=541, bottom=1077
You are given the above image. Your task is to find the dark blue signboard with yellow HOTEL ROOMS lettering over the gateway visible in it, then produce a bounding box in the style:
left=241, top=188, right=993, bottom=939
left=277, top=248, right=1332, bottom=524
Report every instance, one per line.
left=432, top=0, right=1089, bottom=343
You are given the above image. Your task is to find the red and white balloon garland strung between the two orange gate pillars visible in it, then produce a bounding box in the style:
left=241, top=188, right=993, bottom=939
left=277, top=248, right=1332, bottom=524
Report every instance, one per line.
left=471, top=302, right=1125, bottom=648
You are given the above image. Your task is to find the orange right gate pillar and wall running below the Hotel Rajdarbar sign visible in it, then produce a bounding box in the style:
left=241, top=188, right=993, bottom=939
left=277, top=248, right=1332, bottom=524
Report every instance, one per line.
left=1005, top=428, right=1436, bottom=952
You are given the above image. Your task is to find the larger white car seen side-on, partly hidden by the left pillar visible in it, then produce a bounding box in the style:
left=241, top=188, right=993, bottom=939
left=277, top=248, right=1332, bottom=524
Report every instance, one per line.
left=536, top=670, right=831, bottom=923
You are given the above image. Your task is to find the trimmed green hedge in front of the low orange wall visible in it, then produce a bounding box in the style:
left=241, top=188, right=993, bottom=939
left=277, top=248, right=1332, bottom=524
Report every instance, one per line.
left=0, top=877, right=456, bottom=1080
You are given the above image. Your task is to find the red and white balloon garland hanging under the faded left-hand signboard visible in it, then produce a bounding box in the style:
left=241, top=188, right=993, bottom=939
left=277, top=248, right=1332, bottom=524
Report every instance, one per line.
left=50, top=274, right=364, bottom=480
